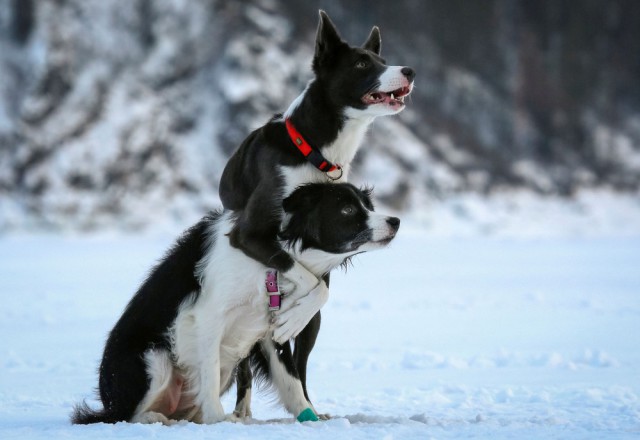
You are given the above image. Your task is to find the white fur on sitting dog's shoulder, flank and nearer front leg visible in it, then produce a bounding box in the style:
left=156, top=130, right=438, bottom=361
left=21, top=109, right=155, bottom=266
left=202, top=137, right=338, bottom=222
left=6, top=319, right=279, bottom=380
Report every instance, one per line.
left=172, top=214, right=270, bottom=423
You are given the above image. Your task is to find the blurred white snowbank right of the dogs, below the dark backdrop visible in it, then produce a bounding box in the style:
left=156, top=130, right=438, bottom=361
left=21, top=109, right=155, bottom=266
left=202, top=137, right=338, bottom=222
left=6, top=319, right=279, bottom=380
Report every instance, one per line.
left=407, top=188, right=640, bottom=238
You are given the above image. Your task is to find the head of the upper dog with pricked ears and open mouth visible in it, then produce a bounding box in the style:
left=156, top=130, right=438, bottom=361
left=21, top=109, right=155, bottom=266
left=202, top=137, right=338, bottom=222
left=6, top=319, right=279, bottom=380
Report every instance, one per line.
left=313, top=11, right=415, bottom=117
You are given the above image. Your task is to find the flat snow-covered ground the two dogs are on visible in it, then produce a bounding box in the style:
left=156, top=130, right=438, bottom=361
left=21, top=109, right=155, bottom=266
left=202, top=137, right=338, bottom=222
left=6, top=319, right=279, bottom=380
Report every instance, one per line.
left=0, top=225, right=640, bottom=440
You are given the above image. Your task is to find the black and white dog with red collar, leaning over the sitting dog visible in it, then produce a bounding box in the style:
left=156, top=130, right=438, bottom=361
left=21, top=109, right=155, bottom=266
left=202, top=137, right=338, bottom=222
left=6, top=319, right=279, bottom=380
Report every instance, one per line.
left=220, top=11, right=415, bottom=416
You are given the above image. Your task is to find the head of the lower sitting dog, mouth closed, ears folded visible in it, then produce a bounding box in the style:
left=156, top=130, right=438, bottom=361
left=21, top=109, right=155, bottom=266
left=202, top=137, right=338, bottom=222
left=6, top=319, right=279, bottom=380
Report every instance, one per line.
left=280, top=183, right=400, bottom=273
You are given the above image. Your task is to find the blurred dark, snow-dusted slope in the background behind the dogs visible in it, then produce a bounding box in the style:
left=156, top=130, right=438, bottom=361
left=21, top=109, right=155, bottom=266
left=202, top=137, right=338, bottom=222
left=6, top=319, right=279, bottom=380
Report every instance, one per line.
left=0, top=0, right=640, bottom=230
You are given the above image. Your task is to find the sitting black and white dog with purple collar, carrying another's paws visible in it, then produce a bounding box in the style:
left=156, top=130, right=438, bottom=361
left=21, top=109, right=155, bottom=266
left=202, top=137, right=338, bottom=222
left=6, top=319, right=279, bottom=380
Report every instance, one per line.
left=72, top=183, right=400, bottom=424
